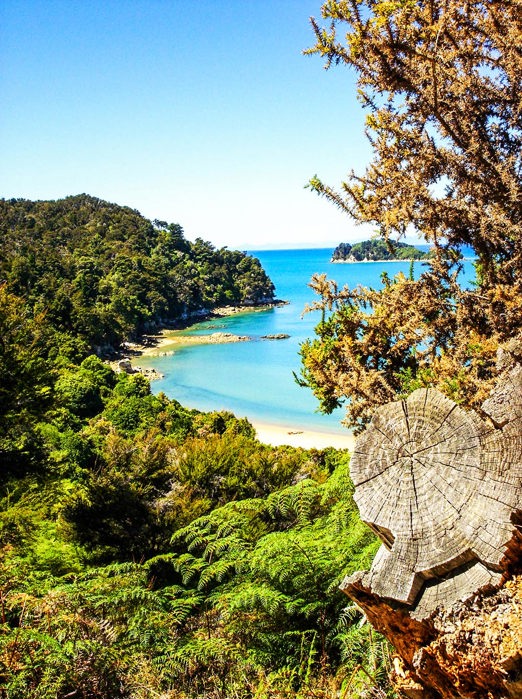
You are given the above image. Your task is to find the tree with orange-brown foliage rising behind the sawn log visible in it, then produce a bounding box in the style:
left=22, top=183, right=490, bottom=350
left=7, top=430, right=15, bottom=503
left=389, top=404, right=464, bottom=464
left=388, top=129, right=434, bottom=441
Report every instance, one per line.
left=302, top=0, right=522, bottom=426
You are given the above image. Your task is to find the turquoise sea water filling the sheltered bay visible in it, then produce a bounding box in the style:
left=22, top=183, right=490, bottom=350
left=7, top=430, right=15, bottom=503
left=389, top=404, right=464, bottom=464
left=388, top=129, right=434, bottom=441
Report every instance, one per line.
left=140, top=248, right=473, bottom=434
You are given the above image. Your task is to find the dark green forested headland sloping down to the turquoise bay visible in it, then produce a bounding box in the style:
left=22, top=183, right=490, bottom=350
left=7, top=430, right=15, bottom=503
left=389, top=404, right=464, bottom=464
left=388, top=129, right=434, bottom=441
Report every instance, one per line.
left=0, top=194, right=274, bottom=352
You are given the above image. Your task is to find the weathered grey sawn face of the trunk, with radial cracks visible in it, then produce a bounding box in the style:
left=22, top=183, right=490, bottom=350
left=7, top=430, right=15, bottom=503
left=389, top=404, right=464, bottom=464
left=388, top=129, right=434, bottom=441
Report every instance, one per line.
left=342, top=357, right=522, bottom=619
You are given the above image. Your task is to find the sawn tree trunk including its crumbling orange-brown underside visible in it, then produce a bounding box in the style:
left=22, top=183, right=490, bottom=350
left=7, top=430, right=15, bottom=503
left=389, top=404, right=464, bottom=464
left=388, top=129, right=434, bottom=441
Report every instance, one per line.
left=342, top=343, right=522, bottom=699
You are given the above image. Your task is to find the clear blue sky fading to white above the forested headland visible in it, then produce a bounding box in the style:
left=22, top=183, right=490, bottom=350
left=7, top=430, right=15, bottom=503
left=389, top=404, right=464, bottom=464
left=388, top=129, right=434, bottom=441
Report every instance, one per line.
left=0, top=0, right=370, bottom=249
